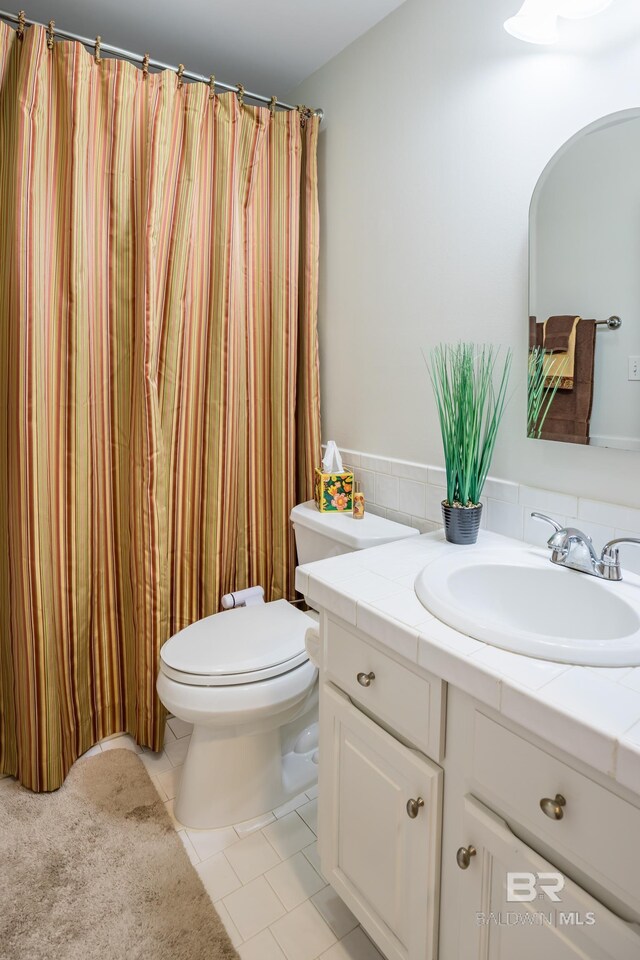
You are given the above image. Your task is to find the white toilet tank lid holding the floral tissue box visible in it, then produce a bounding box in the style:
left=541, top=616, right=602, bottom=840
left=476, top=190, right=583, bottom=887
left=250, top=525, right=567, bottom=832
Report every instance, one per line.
left=291, top=500, right=420, bottom=550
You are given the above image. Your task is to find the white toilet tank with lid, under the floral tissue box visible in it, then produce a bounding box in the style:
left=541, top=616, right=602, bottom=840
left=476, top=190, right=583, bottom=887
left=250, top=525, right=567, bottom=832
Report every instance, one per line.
left=291, top=500, right=420, bottom=564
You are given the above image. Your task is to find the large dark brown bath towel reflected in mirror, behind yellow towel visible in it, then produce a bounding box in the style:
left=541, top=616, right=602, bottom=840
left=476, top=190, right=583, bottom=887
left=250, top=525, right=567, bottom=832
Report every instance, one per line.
left=541, top=320, right=596, bottom=444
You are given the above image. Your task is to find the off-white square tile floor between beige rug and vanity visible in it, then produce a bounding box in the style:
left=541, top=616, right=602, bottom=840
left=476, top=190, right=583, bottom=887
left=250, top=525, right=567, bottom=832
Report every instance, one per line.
left=80, top=717, right=383, bottom=960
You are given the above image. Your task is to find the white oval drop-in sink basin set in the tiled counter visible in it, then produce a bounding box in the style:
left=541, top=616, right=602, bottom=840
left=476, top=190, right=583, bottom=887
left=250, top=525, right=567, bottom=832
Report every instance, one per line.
left=415, top=547, right=640, bottom=667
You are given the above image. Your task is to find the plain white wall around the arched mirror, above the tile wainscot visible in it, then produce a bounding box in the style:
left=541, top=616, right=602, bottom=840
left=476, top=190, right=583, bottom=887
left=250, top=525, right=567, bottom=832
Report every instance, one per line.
left=292, top=0, right=640, bottom=506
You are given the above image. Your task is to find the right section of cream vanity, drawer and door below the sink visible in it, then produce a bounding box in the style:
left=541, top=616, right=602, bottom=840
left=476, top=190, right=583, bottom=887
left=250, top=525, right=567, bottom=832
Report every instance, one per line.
left=440, top=689, right=640, bottom=960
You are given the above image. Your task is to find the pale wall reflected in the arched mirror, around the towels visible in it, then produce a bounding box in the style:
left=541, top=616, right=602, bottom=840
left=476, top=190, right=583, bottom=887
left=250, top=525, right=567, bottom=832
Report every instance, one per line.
left=530, top=113, right=640, bottom=451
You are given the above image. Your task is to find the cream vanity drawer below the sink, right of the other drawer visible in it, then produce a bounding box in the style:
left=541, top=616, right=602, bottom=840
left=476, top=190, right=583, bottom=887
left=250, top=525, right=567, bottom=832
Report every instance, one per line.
left=473, top=711, right=640, bottom=910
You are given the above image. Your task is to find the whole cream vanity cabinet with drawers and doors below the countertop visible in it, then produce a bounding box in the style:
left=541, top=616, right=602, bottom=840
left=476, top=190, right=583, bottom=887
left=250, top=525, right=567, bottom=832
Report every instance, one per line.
left=318, top=612, right=640, bottom=960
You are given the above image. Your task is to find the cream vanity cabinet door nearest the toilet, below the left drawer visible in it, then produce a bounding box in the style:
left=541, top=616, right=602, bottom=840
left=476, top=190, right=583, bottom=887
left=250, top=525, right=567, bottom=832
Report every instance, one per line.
left=319, top=684, right=442, bottom=960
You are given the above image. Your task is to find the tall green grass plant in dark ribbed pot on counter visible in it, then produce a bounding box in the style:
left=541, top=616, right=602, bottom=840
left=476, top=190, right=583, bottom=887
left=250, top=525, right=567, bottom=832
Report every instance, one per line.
left=428, top=343, right=511, bottom=544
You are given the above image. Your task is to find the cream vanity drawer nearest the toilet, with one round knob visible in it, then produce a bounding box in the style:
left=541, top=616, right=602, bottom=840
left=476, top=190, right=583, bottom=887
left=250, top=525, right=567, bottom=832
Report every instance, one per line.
left=324, top=620, right=444, bottom=760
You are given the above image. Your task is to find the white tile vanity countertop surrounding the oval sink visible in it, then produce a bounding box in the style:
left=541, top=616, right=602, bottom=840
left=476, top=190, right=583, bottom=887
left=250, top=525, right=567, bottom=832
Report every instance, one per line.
left=296, top=531, right=640, bottom=794
